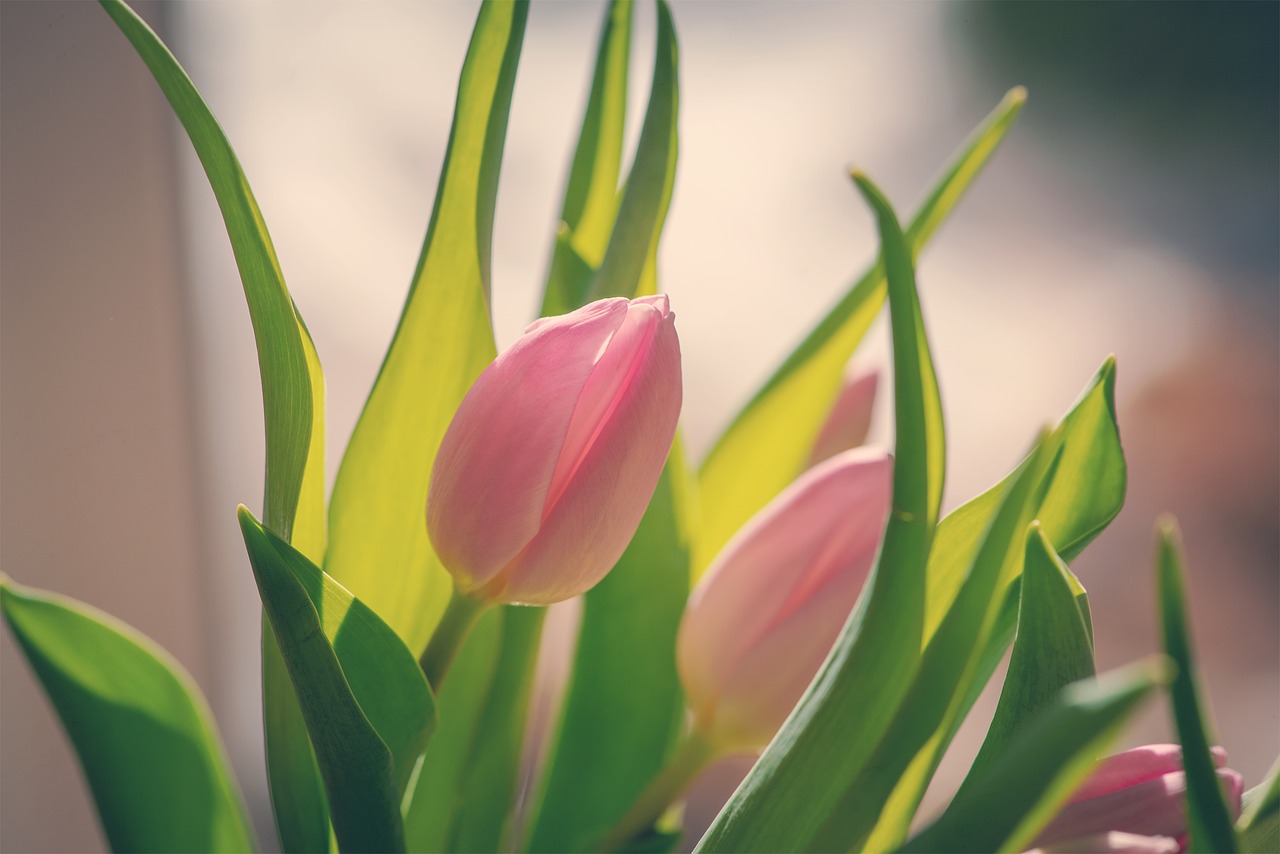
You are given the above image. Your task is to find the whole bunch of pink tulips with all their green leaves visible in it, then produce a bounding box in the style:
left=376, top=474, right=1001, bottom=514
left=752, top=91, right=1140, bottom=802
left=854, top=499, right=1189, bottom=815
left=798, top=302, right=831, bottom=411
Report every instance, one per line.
left=0, top=0, right=1280, bottom=851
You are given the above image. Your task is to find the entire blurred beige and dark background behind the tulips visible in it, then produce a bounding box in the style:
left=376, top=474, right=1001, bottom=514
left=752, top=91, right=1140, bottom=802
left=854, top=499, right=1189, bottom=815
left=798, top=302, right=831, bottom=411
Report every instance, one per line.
left=0, top=0, right=1280, bottom=851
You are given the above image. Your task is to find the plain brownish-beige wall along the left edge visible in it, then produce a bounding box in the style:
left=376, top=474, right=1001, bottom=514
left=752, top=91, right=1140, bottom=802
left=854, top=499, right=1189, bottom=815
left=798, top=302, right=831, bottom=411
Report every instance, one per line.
left=0, top=1, right=211, bottom=851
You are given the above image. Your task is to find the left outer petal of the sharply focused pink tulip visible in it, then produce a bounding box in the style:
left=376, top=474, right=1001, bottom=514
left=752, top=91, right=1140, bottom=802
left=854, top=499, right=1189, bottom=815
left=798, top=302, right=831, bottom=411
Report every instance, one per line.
left=426, top=300, right=627, bottom=592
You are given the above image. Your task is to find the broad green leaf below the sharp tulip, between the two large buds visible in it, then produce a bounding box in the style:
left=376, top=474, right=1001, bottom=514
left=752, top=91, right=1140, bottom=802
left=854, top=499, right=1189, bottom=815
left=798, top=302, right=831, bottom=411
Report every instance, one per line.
left=529, top=440, right=691, bottom=851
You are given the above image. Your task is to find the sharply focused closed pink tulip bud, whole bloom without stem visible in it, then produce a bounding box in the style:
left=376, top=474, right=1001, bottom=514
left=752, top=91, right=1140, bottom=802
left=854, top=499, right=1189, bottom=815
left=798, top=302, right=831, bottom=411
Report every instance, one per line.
left=426, top=296, right=681, bottom=604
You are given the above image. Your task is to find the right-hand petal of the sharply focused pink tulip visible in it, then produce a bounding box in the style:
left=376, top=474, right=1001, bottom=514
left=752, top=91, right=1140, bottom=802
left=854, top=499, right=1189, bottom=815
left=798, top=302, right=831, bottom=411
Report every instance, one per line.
left=486, top=300, right=682, bottom=604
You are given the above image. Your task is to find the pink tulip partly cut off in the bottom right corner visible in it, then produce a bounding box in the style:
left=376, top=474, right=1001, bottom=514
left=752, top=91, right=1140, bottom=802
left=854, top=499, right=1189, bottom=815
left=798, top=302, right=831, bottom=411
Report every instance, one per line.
left=1036, top=744, right=1244, bottom=850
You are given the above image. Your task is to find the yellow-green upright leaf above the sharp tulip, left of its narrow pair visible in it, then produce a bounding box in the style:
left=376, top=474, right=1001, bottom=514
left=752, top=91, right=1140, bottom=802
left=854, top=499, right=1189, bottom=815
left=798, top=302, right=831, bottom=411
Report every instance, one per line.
left=540, top=0, right=634, bottom=318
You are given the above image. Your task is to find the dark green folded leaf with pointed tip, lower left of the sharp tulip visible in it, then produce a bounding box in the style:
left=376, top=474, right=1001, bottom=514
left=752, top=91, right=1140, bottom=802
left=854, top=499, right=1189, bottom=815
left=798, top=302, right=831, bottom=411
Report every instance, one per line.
left=239, top=507, right=435, bottom=851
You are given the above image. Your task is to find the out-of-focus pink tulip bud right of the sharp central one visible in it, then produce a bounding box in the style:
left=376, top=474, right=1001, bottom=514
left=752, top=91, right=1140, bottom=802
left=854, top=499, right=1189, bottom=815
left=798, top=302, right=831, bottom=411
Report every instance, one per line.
left=677, top=448, right=891, bottom=750
